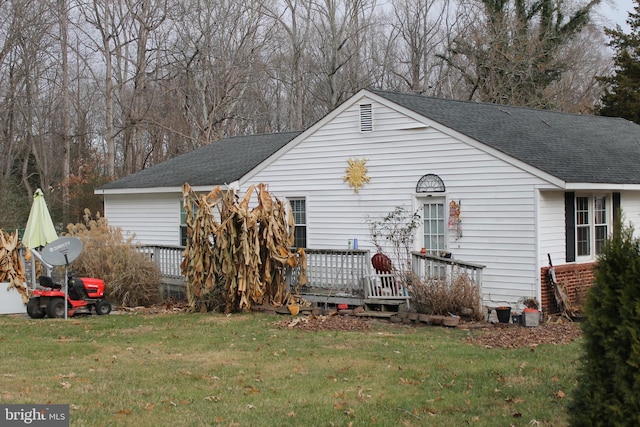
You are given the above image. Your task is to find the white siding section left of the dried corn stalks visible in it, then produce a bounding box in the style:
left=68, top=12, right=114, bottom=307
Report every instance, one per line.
left=104, top=193, right=182, bottom=245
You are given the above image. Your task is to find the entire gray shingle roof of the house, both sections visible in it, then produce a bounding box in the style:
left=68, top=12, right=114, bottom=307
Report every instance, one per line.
left=100, top=90, right=640, bottom=190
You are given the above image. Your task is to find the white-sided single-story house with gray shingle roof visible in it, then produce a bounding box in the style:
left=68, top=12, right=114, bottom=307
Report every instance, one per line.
left=96, top=90, right=640, bottom=309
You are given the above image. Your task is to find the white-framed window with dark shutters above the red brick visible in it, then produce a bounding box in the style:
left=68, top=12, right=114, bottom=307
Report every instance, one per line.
left=575, top=195, right=610, bottom=257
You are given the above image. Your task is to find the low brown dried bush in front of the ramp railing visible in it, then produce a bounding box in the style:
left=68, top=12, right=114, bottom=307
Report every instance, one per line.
left=408, top=274, right=482, bottom=320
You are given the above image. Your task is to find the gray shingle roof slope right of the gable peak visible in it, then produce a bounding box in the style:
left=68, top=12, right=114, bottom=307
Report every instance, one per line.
left=371, top=90, right=640, bottom=184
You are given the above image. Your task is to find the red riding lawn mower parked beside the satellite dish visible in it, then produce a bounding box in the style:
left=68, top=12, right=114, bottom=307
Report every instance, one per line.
left=27, top=275, right=111, bottom=319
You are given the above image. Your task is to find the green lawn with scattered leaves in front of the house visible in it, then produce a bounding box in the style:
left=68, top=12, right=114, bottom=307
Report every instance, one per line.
left=0, top=313, right=580, bottom=426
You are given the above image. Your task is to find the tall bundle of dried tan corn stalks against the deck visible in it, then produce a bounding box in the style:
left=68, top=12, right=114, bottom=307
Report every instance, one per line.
left=182, top=184, right=305, bottom=312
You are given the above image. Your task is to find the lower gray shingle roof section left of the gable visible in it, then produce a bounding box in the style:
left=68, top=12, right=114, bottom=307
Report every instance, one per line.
left=100, top=132, right=300, bottom=190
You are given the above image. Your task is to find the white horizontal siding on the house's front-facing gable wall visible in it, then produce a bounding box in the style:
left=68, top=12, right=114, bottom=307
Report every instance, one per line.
left=248, top=98, right=542, bottom=304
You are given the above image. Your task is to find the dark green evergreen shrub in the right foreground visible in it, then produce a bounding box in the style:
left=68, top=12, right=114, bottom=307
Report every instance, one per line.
left=569, top=224, right=640, bottom=427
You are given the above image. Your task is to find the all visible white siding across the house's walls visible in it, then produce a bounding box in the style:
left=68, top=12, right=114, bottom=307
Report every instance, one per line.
left=105, top=94, right=640, bottom=305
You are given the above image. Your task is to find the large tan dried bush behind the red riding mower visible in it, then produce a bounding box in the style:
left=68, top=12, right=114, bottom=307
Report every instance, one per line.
left=67, top=209, right=161, bottom=307
